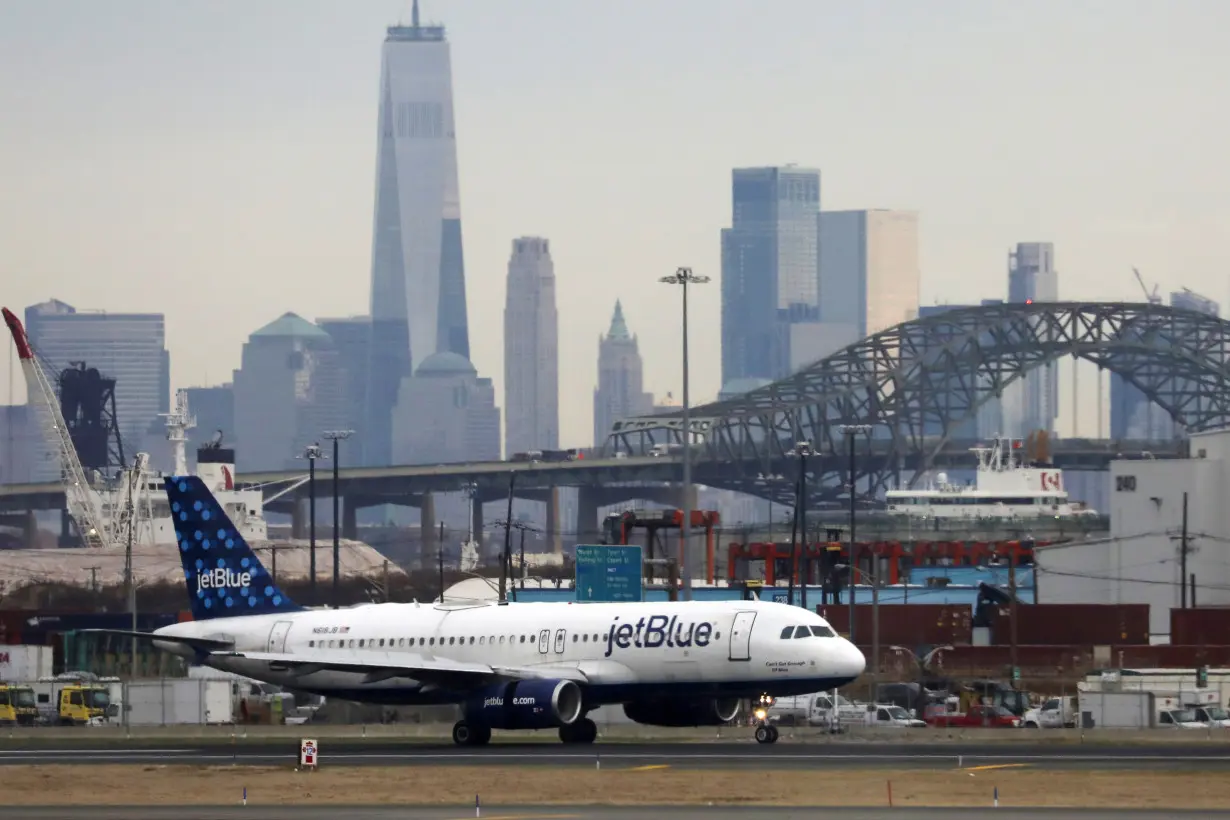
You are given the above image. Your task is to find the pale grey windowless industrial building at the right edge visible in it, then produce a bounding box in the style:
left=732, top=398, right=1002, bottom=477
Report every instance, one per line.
left=1036, top=429, right=1230, bottom=643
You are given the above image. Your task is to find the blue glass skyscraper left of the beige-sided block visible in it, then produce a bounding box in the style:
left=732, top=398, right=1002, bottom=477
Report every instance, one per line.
left=722, top=165, right=820, bottom=385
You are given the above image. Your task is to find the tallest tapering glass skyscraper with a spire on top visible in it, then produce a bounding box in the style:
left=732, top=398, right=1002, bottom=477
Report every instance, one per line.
left=364, top=0, right=470, bottom=463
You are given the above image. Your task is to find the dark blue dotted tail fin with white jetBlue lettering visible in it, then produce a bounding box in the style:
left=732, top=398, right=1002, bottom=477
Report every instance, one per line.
left=164, top=476, right=303, bottom=621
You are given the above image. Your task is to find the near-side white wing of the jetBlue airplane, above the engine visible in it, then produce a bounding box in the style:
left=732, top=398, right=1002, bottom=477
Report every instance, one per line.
left=210, top=652, right=589, bottom=686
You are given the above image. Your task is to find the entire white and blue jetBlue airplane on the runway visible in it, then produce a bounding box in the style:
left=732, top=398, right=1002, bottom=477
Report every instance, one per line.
left=95, top=476, right=865, bottom=745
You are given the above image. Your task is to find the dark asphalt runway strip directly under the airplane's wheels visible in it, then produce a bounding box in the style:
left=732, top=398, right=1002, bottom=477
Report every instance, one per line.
left=0, top=739, right=1230, bottom=771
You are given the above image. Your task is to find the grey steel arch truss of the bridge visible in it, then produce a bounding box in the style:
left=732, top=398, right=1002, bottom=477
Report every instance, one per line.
left=605, top=302, right=1230, bottom=500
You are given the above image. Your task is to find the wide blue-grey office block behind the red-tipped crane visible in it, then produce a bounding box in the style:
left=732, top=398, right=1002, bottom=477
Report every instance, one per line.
left=26, top=299, right=171, bottom=472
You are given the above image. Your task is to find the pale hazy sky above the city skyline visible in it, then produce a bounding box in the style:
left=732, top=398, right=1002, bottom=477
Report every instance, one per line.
left=0, top=0, right=1230, bottom=445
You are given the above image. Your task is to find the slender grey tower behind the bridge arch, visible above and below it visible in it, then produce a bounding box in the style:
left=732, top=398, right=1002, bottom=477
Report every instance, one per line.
left=1002, top=242, right=1059, bottom=438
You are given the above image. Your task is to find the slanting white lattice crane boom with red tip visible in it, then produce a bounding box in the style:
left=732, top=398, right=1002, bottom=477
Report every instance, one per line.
left=0, top=307, right=111, bottom=547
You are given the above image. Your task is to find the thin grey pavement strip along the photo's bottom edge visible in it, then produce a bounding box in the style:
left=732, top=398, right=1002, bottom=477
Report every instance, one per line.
left=0, top=805, right=1226, bottom=820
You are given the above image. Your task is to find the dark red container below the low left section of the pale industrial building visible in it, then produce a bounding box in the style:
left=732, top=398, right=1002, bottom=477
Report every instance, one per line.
left=995, top=604, right=1149, bottom=647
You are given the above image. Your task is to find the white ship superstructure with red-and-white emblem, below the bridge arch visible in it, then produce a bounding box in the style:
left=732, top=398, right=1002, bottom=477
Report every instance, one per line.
left=884, top=436, right=1097, bottom=519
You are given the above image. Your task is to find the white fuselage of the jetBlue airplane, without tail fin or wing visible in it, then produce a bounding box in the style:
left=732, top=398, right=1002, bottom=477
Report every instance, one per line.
left=155, top=601, right=863, bottom=708
